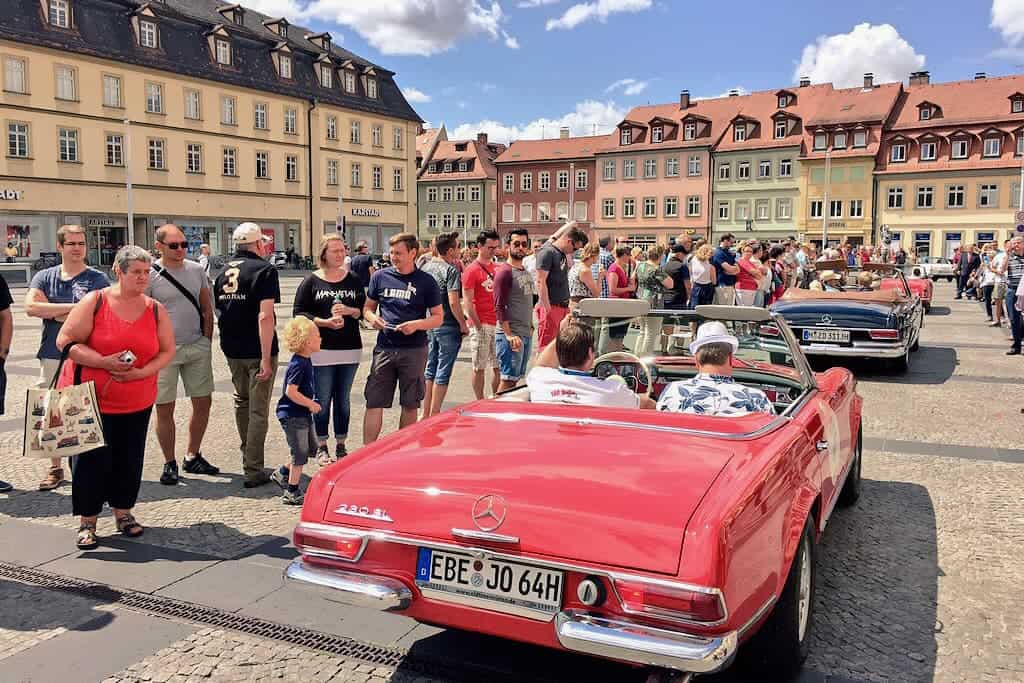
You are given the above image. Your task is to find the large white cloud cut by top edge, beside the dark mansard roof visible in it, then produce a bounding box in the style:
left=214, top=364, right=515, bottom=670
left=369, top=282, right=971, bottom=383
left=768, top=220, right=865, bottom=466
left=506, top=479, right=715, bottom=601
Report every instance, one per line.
left=299, top=0, right=519, bottom=55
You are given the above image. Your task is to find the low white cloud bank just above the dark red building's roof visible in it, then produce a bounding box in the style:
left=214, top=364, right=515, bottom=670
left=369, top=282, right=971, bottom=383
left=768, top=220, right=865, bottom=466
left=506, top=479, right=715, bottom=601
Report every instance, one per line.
left=449, top=100, right=626, bottom=142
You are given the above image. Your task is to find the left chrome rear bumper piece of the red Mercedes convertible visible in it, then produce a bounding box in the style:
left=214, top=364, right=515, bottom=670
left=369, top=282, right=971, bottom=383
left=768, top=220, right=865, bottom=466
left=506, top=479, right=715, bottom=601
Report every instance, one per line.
left=285, top=559, right=413, bottom=611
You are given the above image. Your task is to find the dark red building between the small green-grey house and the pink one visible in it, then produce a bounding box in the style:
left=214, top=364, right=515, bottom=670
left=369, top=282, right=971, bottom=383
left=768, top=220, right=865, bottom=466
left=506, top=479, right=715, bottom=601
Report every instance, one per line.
left=495, top=129, right=611, bottom=237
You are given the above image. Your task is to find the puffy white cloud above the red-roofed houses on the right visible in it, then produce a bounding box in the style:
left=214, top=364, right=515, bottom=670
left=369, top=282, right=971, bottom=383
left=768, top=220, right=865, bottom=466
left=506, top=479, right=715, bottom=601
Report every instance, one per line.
left=794, top=23, right=925, bottom=88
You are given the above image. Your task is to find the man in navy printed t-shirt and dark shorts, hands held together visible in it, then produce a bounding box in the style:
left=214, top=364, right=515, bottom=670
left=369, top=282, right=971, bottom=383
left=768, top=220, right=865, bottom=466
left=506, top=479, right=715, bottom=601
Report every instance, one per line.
left=362, top=232, right=444, bottom=443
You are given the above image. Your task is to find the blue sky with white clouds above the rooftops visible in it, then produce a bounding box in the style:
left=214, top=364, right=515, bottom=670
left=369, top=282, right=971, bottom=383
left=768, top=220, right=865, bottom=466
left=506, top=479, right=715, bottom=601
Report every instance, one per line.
left=251, top=0, right=1024, bottom=141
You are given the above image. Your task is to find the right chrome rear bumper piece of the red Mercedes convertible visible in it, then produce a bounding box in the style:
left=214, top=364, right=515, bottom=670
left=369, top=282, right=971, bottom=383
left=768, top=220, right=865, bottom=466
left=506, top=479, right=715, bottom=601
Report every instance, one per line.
left=555, top=610, right=738, bottom=674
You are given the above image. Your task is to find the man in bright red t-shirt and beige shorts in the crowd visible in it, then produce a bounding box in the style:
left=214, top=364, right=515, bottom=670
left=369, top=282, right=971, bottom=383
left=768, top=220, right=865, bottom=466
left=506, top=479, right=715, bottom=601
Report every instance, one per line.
left=462, top=230, right=502, bottom=399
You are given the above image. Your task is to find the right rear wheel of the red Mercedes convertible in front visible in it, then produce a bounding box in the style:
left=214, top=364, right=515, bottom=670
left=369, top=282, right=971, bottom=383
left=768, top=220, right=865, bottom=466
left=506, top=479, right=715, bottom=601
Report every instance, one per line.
left=751, top=517, right=817, bottom=680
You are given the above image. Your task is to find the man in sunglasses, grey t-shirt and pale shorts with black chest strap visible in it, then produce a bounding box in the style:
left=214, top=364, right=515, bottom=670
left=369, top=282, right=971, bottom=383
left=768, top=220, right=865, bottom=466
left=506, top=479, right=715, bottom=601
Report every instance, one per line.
left=145, top=223, right=220, bottom=486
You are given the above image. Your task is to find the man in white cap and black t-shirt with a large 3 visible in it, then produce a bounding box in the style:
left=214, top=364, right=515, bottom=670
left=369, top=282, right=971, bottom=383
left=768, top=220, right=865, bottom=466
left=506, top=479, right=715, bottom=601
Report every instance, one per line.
left=213, top=223, right=281, bottom=488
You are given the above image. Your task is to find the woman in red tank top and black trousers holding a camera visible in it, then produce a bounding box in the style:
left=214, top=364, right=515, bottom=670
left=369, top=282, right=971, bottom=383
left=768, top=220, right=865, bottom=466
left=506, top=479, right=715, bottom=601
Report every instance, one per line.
left=57, top=246, right=174, bottom=550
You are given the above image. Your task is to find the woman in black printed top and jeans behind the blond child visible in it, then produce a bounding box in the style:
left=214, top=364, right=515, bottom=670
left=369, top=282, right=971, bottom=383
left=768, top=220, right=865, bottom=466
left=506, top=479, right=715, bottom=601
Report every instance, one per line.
left=292, top=234, right=367, bottom=466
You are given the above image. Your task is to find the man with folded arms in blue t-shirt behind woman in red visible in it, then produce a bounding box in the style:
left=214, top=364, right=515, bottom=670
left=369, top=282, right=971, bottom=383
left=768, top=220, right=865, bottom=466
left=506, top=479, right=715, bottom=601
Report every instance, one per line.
left=25, top=225, right=111, bottom=490
